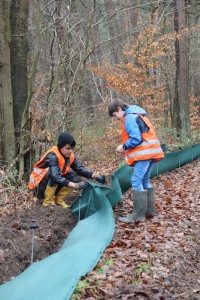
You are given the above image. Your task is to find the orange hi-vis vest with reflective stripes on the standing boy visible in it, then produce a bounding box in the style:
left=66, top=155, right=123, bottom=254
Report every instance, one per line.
left=122, top=114, right=164, bottom=166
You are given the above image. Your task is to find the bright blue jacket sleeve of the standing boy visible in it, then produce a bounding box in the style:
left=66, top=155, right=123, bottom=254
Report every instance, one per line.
left=123, top=114, right=142, bottom=149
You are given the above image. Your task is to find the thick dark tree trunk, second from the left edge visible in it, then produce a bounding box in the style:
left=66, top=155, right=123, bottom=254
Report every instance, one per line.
left=10, top=0, right=30, bottom=173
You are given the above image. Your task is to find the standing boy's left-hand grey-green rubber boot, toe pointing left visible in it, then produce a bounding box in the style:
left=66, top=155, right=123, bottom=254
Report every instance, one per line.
left=119, top=190, right=147, bottom=223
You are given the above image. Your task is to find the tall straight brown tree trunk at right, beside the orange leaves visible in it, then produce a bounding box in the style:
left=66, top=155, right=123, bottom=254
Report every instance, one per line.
left=172, top=0, right=190, bottom=136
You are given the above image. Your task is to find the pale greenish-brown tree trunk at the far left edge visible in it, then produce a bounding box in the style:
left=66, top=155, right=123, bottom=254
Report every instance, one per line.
left=0, top=0, right=15, bottom=163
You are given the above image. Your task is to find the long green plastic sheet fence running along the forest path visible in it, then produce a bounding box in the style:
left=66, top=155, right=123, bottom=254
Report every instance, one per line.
left=0, top=144, right=200, bottom=300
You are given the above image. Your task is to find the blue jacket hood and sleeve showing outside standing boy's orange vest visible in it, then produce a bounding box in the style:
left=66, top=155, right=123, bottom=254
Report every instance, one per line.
left=123, top=105, right=149, bottom=149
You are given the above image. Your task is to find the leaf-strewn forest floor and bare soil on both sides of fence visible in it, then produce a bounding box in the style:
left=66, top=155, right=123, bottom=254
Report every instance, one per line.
left=0, top=160, right=200, bottom=300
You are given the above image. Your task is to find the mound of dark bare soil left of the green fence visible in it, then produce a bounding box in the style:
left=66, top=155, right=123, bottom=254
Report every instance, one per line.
left=0, top=203, right=77, bottom=284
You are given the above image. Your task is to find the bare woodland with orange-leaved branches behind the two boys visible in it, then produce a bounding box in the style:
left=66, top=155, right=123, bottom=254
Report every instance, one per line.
left=0, top=0, right=200, bottom=183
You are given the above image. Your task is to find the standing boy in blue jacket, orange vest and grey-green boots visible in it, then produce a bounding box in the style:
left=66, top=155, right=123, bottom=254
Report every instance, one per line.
left=108, top=100, right=164, bottom=223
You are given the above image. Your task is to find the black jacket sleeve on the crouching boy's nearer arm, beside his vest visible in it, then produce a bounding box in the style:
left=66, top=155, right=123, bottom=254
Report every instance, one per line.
left=45, top=152, right=69, bottom=186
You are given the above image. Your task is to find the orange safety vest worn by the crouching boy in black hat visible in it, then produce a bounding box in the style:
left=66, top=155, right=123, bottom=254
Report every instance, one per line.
left=28, top=146, right=74, bottom=190
